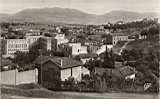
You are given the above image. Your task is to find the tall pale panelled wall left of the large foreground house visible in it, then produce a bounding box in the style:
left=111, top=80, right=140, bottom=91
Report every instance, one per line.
left=0, top=69, right=38, bottom=85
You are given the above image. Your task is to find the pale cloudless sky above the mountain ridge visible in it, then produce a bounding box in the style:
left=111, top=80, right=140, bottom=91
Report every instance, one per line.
left=0, top=0, right=160, bottom=14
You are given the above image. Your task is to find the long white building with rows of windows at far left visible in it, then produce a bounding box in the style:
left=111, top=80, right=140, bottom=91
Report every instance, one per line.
left=2, top=39, right=29, bottom=56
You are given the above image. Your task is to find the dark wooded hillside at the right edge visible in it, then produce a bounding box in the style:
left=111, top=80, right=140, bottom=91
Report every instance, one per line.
left=122, top=26, right=160, bottom=92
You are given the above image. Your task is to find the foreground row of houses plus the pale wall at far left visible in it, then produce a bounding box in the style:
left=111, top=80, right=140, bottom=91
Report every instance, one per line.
left=1, top=54, right=137, bottom=90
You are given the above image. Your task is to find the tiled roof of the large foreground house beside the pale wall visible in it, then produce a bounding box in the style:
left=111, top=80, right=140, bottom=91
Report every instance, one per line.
left=34, top=56, right=82, bottom=69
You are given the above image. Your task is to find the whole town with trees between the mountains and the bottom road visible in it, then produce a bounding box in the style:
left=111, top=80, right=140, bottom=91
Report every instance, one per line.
left=0, top=18, right=160, bottom=98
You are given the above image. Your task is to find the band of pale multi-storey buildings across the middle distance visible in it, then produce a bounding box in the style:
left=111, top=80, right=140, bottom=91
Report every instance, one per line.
left=1, top=29, right=139, bottom=57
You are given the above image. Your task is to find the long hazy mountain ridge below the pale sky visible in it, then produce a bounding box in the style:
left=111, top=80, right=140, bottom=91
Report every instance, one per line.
left=0, top=7, right=158, bottom=24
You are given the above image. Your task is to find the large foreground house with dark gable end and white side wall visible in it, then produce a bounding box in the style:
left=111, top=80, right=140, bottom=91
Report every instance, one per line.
left=34, top=56, right=89, bottom=89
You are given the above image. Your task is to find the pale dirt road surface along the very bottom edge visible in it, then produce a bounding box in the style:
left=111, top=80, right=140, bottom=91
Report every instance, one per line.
left=2, top=92, right=159, bottom=99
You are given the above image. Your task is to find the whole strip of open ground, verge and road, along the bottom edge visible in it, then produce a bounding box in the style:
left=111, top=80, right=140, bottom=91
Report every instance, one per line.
left=1, top=86, right=159, bottom=99
